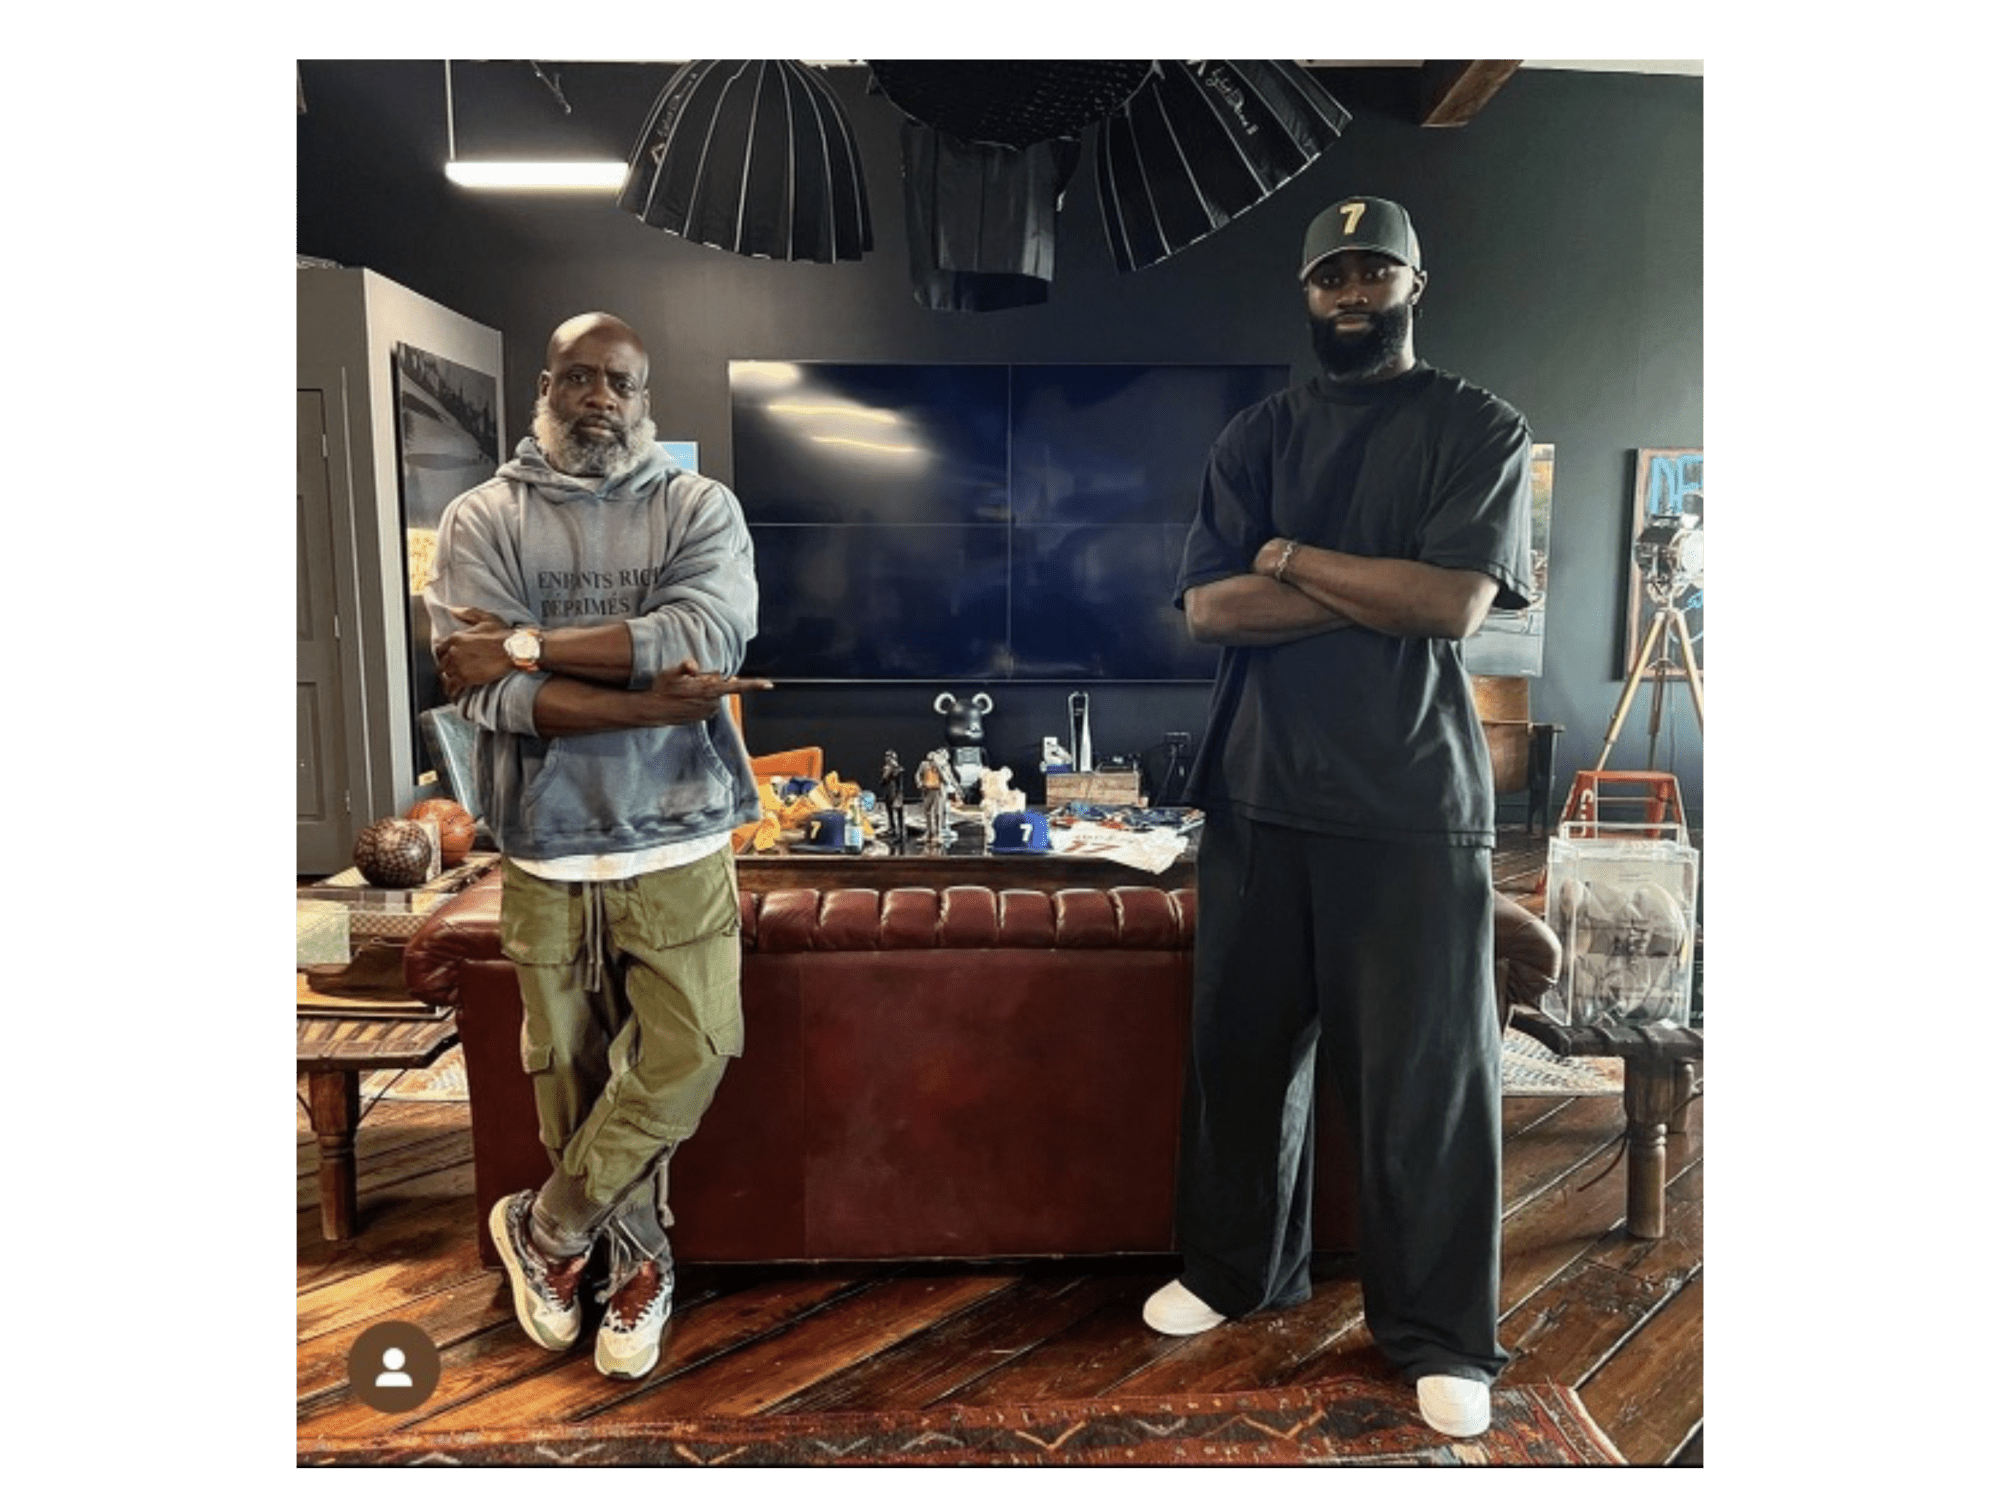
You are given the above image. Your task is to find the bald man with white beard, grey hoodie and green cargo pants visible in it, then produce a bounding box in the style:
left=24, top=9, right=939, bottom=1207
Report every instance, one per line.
left=426, top=312, right=770, bottom=1380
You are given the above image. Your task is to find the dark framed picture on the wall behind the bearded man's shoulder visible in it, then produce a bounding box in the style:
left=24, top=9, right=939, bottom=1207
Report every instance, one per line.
left=394, top=344, right=500, bottom=774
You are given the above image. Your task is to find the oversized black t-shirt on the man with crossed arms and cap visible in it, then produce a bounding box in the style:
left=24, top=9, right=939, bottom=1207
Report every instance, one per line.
left=1174, top=364, right=1534, bottom=846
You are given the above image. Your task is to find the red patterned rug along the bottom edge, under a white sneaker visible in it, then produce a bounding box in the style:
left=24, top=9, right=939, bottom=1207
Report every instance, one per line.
left=298, top=1376, right=1624, bottom=1468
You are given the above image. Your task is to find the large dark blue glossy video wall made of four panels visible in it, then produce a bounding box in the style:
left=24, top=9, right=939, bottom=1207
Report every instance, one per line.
left=730, top=360, right=1290, bottom=682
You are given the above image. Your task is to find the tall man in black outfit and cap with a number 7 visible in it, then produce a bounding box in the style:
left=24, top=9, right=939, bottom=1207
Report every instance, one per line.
left=1146, top=198, right=1532, bottom=1436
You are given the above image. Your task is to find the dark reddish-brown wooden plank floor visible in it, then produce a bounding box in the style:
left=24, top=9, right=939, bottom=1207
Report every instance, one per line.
left=298, top=1072, right=1702, bottom=1464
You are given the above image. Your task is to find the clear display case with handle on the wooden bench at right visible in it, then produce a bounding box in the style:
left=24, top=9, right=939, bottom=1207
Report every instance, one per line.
left=1542, top=822, right=1702, bottom=1026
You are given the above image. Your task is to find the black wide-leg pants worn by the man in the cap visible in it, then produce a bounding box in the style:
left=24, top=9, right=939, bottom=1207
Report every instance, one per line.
left=1176, top=818, right=1506, bottom=1380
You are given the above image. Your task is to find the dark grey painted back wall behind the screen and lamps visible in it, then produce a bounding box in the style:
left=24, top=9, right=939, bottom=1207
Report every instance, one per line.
left=298, top=60, right=1704, bottom=818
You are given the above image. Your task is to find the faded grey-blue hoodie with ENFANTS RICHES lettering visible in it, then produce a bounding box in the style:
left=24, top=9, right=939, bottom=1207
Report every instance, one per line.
left=424, top=438, right=758, bottom=860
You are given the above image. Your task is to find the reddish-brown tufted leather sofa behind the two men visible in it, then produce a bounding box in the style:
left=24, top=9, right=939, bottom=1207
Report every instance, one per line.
left=404, top=874, right=1558, bottom=1264
